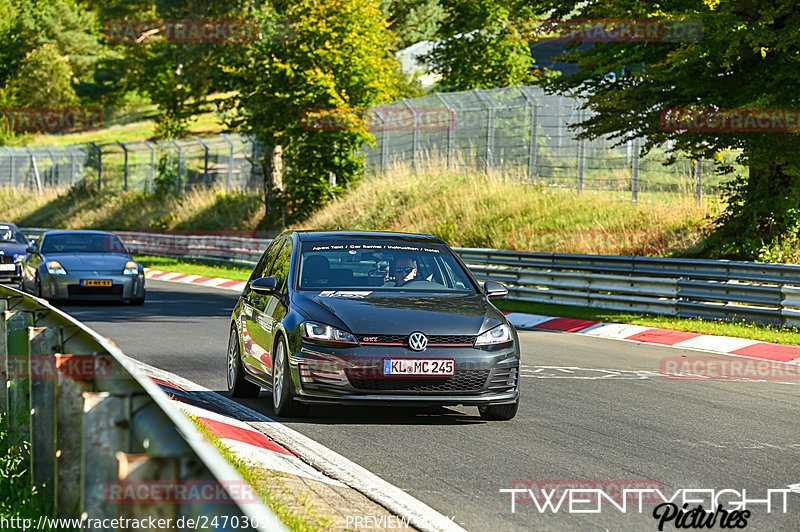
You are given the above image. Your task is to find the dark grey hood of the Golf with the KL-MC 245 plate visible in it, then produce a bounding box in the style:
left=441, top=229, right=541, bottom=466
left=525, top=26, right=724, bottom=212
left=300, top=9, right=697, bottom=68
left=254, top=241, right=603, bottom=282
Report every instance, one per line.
left=293, top=291, right=505, bottom=335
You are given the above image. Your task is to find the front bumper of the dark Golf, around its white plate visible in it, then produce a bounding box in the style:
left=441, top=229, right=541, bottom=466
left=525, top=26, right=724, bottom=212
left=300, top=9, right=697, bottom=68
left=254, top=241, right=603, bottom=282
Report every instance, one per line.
left=290, top=345, right=519, bottom=406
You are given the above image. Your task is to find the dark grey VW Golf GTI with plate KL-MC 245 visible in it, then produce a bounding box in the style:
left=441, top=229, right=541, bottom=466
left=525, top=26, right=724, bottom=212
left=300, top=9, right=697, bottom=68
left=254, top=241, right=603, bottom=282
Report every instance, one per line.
left=227, top=231, right=520, bottom=420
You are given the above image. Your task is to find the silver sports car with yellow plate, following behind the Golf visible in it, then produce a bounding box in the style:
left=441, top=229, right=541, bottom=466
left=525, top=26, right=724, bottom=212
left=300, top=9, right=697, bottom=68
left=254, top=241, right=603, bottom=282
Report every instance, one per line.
left=22, top=230, right=145, bottom=305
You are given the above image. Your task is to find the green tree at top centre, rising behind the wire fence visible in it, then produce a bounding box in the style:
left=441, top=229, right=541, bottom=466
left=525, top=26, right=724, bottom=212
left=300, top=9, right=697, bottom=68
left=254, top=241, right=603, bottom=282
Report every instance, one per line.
left=424, top=0, right=544, bottom=90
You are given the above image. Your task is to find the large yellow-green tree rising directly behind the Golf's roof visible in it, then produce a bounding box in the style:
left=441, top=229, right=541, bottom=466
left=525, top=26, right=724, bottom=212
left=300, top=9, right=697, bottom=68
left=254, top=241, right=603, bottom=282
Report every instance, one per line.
left=228, top=0, right=400, bottom=217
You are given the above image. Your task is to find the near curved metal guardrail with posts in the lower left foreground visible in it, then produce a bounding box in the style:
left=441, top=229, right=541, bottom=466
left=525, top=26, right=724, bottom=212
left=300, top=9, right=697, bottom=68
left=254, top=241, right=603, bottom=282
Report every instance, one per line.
left=0, top=285, right=285, bottom=531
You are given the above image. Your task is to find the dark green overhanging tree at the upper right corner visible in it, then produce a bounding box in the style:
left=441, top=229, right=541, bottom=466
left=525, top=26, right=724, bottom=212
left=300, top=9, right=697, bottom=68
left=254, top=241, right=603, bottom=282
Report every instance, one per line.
left=539, top=0, right=800, bottom=259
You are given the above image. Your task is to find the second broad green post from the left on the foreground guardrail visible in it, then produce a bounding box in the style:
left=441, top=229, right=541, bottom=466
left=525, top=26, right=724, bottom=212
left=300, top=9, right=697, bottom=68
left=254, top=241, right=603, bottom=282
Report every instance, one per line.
left=28, top=327, right=59, bottom=510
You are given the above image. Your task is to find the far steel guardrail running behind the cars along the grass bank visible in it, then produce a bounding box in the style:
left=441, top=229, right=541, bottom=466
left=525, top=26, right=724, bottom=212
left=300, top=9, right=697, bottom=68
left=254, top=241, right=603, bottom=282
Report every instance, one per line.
left=17, top=230, right=800, bottom=326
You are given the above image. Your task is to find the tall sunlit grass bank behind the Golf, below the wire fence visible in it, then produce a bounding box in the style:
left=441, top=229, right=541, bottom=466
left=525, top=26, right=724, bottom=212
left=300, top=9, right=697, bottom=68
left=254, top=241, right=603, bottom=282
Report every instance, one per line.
left=298, top=172, right=719, bottom=255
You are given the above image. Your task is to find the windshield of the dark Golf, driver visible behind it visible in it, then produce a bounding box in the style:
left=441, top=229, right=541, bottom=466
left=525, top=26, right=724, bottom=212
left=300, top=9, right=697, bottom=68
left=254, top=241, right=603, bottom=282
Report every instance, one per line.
left=297, top=240, right=475, bottom=293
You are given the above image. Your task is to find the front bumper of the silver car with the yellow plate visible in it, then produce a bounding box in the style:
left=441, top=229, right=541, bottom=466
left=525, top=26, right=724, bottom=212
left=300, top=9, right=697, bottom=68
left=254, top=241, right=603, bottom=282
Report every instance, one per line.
left=42, top=274, right=144, bottom=301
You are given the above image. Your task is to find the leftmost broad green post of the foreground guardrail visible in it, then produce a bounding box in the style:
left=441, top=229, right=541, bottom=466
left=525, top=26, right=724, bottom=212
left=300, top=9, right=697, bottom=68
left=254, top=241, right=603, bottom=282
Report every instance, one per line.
left=4, top=311, right=33, bottom=445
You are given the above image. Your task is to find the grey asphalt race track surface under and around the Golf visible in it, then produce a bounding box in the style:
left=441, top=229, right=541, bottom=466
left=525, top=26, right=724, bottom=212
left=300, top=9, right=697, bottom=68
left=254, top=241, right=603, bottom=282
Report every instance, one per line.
left=61, top=281, right=800, bottom=532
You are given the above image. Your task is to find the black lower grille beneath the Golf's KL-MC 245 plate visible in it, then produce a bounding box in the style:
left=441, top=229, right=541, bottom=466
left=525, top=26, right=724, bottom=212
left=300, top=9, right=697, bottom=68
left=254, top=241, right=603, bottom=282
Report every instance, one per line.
left=346, top=369, right=489, bottom=393
